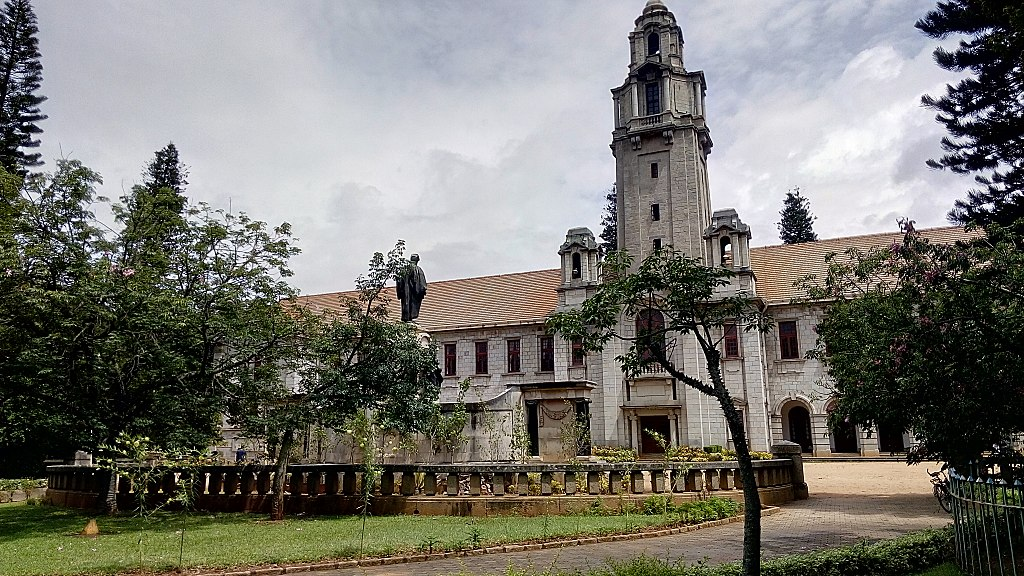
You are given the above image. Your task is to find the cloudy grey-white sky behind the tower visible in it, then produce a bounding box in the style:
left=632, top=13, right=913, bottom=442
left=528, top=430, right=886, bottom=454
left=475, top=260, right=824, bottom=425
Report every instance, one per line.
left=34, top=0, right=972, bottom=294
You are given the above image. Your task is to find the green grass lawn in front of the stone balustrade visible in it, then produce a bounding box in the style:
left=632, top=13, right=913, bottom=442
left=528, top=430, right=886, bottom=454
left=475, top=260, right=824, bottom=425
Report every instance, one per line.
left=0, top=502, right=700, bottom=576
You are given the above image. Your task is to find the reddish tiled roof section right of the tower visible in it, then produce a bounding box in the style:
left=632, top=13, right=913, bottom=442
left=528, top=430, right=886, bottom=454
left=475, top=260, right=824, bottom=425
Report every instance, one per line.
left=751, top=227, right=974, bottom=303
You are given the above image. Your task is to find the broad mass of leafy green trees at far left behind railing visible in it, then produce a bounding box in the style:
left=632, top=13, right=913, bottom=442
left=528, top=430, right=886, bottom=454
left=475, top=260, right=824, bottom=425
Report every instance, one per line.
left=0, top=154, right=298, bottom=485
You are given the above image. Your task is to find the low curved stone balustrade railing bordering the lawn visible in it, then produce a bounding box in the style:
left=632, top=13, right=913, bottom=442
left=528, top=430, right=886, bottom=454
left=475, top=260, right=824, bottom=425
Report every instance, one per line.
left=46, top=440, right=806, bottom=516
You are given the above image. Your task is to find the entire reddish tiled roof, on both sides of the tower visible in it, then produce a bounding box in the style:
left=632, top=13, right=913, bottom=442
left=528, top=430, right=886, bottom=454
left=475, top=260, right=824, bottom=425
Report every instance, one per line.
left=299, top=227, right=970, bottom=332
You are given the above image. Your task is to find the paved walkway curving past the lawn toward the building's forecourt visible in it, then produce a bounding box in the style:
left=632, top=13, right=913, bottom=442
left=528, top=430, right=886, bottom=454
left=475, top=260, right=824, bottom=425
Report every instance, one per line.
left=306, top=462, right=949, bottom=576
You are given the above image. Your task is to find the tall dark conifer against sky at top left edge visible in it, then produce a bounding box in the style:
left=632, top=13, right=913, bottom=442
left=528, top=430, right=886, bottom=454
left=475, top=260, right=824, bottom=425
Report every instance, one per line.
left=0, top=0, right=46, bottom=175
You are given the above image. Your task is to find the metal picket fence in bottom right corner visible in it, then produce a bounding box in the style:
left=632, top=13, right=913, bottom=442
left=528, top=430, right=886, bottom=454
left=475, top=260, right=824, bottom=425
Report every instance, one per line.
left=949, top=461, right=1024, bottom=576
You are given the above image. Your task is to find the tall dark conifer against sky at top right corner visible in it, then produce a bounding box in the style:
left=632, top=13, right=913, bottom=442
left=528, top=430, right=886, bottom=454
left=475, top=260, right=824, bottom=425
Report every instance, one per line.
left=916, top=0, right=1024, bottom=227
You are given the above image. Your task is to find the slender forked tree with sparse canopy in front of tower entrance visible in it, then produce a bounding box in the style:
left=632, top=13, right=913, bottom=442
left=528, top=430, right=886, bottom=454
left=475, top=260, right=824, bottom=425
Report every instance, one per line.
left=548, top=250, right=771, bottom=575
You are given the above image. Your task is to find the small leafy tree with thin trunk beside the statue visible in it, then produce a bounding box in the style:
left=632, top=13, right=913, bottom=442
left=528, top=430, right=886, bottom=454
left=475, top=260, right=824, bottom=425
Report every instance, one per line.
left=227, top=242, right=441, bottom=520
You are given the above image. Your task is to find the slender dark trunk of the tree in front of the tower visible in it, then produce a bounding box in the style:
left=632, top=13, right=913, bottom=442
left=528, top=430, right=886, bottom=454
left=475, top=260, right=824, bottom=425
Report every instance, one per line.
left=708, top=358, right=761, bottom=576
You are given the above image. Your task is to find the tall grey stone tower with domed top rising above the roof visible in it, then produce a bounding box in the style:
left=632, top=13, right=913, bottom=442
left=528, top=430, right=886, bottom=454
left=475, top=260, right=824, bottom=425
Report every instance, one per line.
left=611, top=0, right=712, bottom=262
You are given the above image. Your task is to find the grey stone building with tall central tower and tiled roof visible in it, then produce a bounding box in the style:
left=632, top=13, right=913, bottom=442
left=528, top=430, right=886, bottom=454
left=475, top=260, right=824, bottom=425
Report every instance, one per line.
left=249, top=0, right=963, bottom=460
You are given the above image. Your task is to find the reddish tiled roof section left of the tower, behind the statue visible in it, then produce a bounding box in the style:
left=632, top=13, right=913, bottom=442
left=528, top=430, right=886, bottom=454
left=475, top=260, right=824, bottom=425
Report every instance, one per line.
left=299, top=269, right=561, bottom=332
